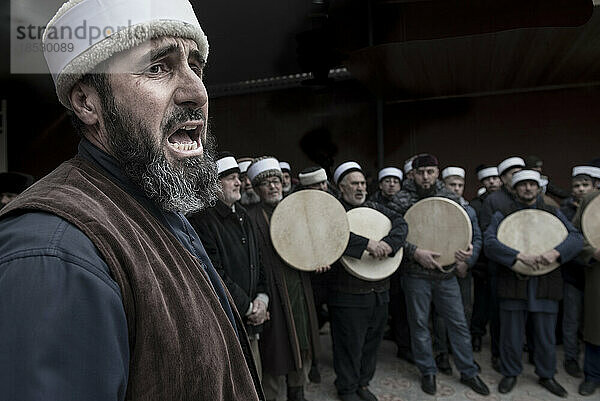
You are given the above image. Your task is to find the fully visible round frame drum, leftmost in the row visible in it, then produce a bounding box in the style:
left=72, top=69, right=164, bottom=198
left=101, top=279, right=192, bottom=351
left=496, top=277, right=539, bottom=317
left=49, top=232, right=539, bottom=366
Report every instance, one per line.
left=270, top=189, right=350, bottom=271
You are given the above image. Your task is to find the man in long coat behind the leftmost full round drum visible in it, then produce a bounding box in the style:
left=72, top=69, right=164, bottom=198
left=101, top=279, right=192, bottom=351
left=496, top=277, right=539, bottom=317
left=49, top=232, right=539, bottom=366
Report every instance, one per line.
left=248, top=156, right=319, bottom=401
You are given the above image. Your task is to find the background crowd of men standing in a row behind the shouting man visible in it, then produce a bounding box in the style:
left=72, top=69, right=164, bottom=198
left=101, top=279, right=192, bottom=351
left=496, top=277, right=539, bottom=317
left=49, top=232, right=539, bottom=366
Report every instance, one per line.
left=184, top=153, right=600, bottom=400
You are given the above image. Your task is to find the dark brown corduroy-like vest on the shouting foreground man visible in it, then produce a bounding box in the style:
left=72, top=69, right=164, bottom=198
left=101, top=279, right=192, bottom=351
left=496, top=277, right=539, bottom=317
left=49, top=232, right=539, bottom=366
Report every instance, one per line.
left=2, top=158, right=264, bottom=401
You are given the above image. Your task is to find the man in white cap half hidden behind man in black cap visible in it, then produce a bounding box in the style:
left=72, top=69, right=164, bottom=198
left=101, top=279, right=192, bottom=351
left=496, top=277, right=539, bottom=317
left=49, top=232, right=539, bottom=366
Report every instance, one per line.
left=433, top=167, right=483, bottom=374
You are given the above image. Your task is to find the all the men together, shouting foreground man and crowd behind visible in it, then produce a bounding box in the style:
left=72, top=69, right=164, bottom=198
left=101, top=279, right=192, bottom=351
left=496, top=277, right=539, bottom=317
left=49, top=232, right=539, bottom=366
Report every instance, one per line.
left=0, top=0, right=600, bottom=401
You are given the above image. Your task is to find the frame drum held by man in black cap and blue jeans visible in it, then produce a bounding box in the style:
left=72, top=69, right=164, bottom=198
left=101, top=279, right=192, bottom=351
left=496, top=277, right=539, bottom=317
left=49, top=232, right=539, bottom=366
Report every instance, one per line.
left=404, top=196, right=473, bottom=272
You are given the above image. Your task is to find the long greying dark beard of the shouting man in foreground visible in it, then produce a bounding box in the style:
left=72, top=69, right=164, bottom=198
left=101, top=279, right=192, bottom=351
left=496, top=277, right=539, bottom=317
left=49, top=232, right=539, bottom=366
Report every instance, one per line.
left=103, top=96, right=218, bottom=214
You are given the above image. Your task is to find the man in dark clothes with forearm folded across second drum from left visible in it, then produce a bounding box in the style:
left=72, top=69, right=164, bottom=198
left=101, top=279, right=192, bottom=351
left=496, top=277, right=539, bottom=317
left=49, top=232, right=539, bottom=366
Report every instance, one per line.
left=327, top=162, right=408, bottom=401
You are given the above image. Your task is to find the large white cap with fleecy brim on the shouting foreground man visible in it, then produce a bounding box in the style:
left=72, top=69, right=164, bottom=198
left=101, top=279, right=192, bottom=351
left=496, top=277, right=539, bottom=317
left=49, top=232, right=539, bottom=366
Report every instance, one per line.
left=42, top=0, right=208, bottom=109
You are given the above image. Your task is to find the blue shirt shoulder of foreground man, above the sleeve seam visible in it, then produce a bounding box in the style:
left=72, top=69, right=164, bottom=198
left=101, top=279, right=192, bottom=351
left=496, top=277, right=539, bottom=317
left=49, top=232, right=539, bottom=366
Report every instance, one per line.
left=0, top=211, right=116, bottom=288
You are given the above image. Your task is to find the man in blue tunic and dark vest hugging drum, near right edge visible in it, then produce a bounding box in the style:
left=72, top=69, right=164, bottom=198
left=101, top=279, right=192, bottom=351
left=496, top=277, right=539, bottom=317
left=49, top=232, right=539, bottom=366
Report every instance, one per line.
left=484, top=170, right=583, bottom=397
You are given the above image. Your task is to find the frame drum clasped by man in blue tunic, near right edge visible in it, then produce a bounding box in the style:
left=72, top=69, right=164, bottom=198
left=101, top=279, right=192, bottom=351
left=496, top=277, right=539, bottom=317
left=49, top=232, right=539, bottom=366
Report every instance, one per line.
left=497, top=209, right=569, bottom=276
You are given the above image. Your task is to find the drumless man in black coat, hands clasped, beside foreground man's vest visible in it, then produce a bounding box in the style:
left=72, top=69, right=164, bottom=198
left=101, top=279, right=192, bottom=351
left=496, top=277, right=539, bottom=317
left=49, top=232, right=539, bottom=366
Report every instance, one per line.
left=188, top=152, right=269, bottom=377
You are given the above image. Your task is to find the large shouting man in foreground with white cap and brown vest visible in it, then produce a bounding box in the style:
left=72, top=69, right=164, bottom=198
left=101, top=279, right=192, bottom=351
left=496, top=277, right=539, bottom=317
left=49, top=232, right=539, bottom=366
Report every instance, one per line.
left=0, top=0, right=263, bottom=401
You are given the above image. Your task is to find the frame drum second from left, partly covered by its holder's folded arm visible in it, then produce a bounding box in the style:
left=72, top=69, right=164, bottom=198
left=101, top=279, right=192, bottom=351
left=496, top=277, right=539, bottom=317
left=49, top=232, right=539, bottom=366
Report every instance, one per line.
left=340, top=207, right=403, bottom=281
